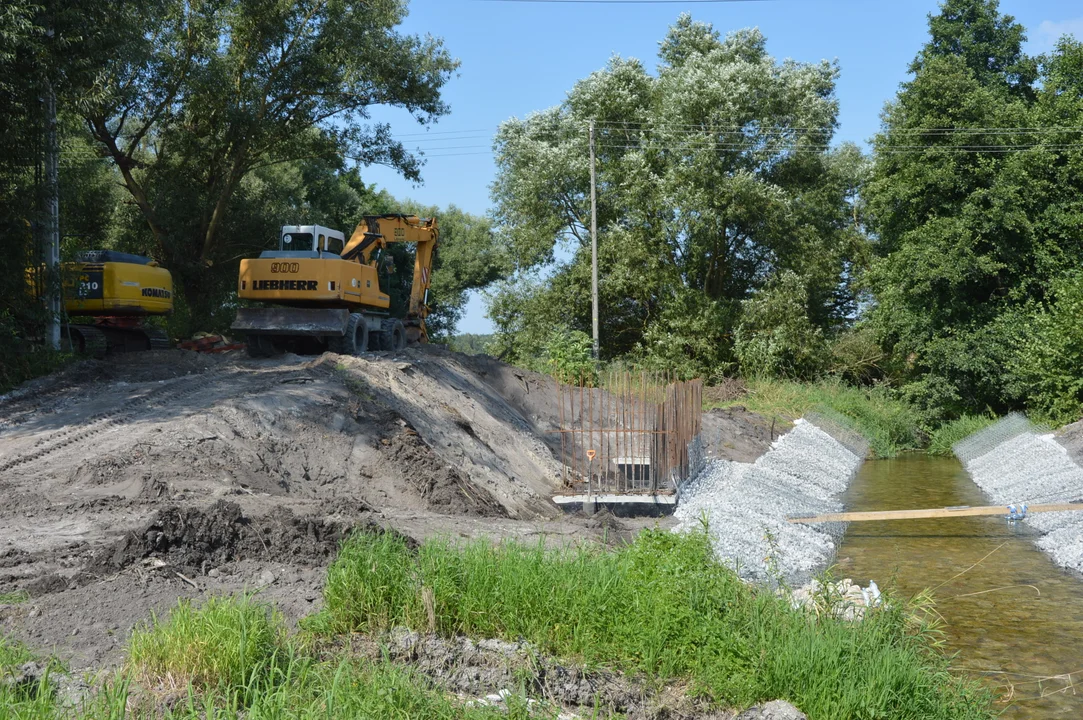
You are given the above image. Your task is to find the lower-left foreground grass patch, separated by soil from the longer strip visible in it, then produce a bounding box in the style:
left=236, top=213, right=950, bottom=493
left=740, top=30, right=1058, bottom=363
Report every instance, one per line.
left=0, top=595, right=545, bottom=720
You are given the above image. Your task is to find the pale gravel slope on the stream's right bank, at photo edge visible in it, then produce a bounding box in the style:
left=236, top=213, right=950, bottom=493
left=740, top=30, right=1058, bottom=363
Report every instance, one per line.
left=960, top=426, right=1083, bottom=570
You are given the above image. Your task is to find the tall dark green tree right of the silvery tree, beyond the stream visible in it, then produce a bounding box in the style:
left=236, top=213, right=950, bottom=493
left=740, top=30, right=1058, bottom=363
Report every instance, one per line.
left=864, top=0, right=1044, bottom=422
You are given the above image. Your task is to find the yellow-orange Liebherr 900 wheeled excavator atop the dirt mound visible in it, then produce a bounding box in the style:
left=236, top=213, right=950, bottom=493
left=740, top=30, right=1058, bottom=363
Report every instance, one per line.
left=233, top=214, right=440, bottom=357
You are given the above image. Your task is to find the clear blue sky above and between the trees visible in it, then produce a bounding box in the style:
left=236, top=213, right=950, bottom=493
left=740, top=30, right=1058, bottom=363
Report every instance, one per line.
left=363, top=0, right=1083, bottom=332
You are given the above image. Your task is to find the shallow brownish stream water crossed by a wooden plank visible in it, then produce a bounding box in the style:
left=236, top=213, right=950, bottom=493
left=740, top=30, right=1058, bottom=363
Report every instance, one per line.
left=837, top=455, right=1083, bottom=718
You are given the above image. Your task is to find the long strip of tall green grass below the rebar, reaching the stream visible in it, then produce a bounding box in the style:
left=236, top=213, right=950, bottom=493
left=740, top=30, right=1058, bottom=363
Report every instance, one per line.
left=309, top=532, right=992, bottom=720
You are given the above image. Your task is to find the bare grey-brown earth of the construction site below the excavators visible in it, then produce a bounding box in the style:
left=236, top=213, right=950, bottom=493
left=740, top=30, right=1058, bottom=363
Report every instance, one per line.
left=0, top=346, right=781, bottom=669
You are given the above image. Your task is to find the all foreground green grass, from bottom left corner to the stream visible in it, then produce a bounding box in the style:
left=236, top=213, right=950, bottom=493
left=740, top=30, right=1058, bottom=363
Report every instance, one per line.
left=0, top=532, right=993, bottom=720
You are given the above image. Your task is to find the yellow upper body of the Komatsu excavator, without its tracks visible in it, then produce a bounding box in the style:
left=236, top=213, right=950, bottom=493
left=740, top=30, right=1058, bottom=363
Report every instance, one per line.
left=61, top=256, right=173, bottom=317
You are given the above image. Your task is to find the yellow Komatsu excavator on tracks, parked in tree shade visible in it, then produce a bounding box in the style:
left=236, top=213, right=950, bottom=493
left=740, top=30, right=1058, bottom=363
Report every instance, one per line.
left=27, top=250, right=173, bottom=357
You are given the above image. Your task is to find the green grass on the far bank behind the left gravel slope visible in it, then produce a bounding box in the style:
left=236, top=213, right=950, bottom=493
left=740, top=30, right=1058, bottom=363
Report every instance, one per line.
left=704, top=380, right=923, bottom=458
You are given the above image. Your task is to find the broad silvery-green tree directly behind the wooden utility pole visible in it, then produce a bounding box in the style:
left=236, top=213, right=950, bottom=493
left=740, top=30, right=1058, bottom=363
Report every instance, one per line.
left=491, top=15, right=863, bottom=374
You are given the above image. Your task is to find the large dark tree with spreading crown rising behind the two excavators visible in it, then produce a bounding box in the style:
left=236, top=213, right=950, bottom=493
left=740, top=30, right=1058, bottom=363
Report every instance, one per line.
left=80, top=0, right=458, bottom=329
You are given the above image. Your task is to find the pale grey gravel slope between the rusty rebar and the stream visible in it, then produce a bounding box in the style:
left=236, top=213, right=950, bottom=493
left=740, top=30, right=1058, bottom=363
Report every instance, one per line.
left=674, top=420, right=863, bottom=586
